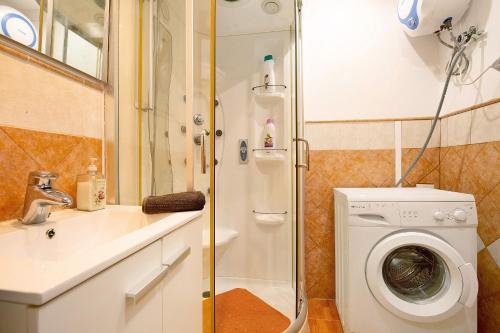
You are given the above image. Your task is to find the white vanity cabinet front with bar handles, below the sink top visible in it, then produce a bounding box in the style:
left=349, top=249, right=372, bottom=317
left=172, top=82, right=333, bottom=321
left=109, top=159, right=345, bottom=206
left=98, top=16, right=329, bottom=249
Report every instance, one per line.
left=0, top=217, right=202, bottom=333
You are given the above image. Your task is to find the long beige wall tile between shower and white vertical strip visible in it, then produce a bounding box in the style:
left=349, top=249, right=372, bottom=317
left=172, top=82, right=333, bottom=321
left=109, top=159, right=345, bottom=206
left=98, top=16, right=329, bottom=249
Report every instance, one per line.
left=305, top=121, right=394, bottom=150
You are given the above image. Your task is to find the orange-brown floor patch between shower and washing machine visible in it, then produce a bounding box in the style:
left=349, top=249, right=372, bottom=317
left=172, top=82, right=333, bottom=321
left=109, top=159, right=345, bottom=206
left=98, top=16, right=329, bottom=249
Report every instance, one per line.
left=309, top=299, right=343, bottom=333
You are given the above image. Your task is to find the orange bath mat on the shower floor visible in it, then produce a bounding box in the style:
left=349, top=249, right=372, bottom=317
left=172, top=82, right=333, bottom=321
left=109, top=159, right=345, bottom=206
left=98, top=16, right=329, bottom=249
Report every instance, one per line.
left=205, top=288, right=290, bottom=333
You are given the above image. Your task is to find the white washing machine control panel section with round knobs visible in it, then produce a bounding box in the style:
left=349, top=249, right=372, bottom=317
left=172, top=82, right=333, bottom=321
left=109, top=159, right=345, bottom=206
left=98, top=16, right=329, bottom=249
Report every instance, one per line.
left=400, top=202, right=477, bottom=226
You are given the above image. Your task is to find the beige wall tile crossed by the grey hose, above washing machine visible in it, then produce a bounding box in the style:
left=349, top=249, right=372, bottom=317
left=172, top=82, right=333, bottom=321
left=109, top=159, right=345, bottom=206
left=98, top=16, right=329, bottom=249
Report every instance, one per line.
left=401, top=120, right=441, bottom=148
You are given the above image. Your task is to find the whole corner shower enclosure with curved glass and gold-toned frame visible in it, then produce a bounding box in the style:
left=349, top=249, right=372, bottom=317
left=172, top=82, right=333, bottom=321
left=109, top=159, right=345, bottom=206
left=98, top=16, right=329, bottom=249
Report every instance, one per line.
left=115, top=0, right=308, bottom=332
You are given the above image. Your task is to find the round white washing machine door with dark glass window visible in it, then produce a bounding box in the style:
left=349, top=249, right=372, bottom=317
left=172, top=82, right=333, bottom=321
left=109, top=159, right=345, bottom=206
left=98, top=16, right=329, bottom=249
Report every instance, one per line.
left=366, top=231, right=478, bottom=322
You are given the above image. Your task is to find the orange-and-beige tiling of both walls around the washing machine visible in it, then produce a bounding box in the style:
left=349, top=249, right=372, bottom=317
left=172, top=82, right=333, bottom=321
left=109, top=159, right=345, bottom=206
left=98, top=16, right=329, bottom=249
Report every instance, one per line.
left=305, top=99, right=500, bottom=333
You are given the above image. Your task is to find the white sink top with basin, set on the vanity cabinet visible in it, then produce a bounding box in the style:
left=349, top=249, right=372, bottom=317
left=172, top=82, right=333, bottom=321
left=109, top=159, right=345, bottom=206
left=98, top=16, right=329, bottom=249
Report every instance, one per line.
left=0, top=206, right=201, bottom=305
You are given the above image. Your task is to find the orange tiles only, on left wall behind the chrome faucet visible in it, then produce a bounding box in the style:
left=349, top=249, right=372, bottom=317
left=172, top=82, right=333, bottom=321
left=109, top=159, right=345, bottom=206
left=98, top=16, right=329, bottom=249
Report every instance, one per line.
left=0, top=126, right=102, bottom=221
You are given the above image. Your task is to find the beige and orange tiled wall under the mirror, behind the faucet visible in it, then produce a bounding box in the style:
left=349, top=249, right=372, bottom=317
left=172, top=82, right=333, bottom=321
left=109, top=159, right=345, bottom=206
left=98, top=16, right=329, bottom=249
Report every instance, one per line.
left=0, top=46, right=105, bottom=221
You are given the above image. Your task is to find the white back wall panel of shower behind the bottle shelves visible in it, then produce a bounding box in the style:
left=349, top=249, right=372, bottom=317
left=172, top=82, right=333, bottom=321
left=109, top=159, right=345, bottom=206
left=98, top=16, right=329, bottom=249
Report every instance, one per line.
left=215, top=30, right=293, bottom=282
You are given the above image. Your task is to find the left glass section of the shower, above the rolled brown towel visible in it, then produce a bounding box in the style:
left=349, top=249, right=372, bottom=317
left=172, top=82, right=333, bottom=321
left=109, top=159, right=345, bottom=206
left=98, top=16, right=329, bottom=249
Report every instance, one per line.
left=117, top=0, right=192, bottom=205
